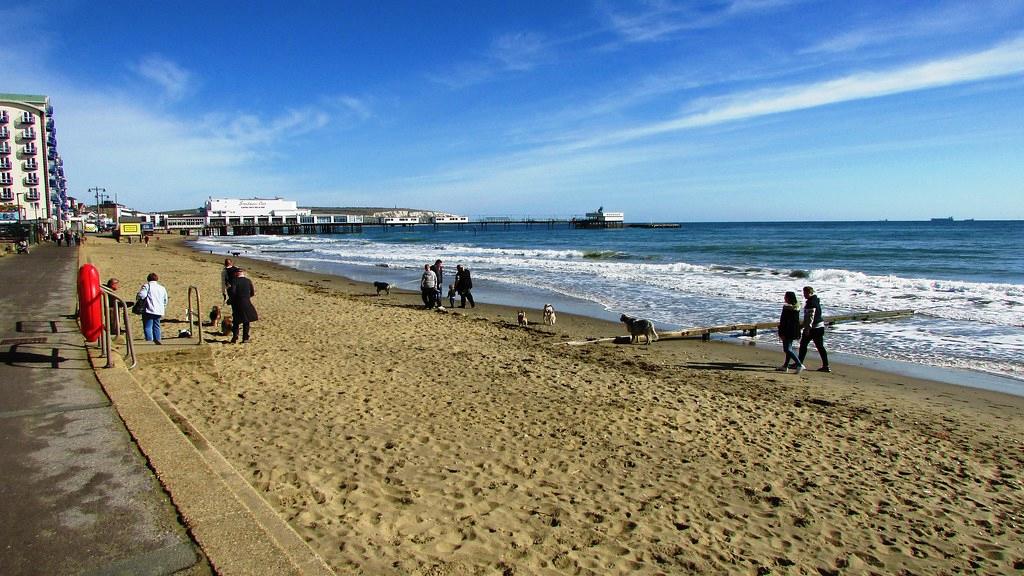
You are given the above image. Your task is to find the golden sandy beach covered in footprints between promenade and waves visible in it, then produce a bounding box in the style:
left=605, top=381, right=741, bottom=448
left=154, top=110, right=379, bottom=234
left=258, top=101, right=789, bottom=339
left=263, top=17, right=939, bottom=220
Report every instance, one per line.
left=82, top=236, right=1024, bottom=575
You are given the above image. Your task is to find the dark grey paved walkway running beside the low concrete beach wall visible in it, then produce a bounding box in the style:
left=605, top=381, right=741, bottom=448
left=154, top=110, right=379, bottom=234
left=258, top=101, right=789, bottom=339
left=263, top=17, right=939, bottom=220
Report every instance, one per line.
left=0, top=244, right=210, bottom=576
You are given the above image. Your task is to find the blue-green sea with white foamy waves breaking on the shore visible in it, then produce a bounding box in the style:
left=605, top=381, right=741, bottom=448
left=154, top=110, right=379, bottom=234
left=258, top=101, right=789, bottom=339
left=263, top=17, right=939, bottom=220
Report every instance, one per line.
left=196, top=220, right=1024, bottom=396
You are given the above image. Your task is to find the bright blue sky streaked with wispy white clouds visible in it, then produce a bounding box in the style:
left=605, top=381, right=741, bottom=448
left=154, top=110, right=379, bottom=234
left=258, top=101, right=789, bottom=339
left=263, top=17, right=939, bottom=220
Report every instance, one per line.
left=0, top=0, right=1024, bottom=221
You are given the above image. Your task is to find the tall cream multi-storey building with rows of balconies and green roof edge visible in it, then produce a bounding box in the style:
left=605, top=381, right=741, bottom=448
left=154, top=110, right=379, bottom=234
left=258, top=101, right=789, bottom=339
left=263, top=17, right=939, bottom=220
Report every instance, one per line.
left=0, top=93, right=71, bottom=234
